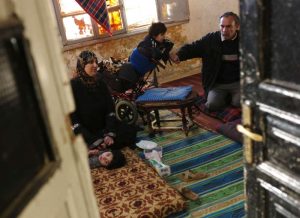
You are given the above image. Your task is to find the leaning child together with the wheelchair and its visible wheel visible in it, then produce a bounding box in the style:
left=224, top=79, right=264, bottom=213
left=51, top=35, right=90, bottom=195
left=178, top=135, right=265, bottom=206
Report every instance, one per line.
left=99, top=22, right=174, bottom=124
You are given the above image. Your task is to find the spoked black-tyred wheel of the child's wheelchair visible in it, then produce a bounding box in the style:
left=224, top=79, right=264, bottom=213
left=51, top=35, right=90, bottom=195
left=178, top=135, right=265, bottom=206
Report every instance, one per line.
left=116, top=100, right=138, bottom=124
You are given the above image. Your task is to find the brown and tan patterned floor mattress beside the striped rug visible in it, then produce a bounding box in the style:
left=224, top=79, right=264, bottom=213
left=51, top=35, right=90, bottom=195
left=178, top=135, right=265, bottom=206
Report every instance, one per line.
left=92, top=148, right=186, bottom=218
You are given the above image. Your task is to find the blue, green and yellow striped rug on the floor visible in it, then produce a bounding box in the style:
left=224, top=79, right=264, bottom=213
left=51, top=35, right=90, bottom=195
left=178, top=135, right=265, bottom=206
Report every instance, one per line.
left=139, top=119, right=245, bottom=218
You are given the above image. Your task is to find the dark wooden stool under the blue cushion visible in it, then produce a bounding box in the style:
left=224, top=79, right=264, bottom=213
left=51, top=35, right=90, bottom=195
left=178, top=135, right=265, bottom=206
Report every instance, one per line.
left=136, top=91, right=197, bottom=136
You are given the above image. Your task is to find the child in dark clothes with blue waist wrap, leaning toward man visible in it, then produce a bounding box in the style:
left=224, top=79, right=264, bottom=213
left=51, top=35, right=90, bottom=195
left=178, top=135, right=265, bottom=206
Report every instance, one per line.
left=99, top=22, right=174, bottom=93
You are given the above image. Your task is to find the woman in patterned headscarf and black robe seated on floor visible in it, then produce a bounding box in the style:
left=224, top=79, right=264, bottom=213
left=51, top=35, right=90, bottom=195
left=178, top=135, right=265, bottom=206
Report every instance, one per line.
left=71, top=51, right=136, bottom=169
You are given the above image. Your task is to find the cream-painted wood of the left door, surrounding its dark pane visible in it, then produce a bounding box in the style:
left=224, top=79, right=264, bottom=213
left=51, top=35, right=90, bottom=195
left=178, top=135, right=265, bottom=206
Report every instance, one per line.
left=0, top=0, right=99, bottom=218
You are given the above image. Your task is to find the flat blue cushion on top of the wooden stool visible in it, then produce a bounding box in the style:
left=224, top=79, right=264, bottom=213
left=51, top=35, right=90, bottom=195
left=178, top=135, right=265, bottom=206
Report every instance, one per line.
left=136, top=86, right=192, bottom=102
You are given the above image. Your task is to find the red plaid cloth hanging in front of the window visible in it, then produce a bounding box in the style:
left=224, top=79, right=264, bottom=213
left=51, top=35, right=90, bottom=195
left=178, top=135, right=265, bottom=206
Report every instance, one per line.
left=76, top=0, right=112, bottom=35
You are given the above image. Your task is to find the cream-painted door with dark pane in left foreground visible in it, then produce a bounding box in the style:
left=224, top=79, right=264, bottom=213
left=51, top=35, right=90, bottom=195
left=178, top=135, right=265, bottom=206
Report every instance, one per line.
left=0, top=0, right=99, bottom=218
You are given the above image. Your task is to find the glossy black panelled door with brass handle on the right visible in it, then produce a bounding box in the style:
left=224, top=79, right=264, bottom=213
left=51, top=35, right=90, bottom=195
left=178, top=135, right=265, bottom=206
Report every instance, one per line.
left=239, top=0, right=300, bottom=218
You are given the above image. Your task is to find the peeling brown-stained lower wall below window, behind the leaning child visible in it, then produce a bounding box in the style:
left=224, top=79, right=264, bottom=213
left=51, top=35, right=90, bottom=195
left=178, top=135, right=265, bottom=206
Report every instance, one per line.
left=64, top=25, right=200, bottom=83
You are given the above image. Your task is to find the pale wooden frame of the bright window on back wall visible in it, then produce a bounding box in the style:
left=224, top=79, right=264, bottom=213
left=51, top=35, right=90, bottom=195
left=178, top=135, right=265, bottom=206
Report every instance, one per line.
left=52, top=0, right=190, bottom=50
